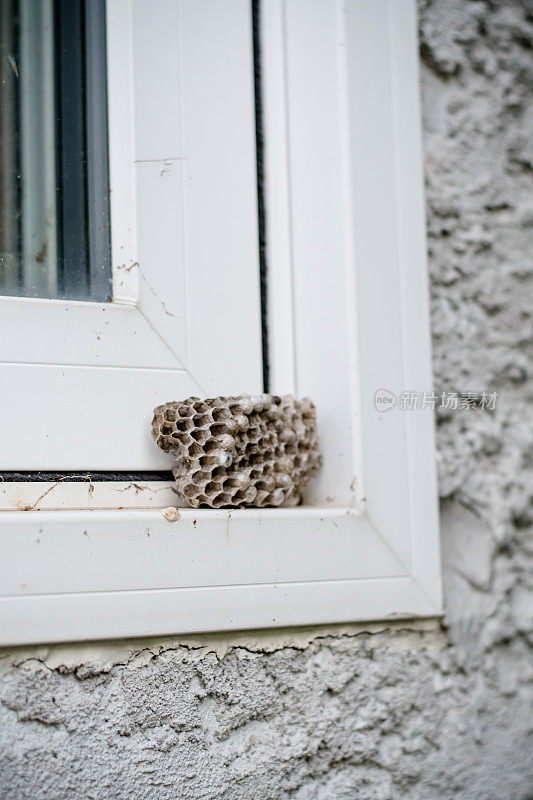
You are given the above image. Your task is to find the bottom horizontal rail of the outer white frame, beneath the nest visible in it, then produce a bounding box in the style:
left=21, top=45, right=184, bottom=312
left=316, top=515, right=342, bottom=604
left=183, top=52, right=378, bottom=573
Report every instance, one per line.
left=0, top=507, right=440, bottom=645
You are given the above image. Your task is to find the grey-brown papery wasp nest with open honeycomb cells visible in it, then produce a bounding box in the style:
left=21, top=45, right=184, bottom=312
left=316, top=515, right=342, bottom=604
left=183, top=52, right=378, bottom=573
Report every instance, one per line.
left=152, top=394, right=320, bottom=508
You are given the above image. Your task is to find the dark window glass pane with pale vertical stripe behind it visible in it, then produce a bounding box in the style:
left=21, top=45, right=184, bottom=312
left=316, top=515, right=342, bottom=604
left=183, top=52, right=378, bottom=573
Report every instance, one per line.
left=0, top=0, right=111, bottom=301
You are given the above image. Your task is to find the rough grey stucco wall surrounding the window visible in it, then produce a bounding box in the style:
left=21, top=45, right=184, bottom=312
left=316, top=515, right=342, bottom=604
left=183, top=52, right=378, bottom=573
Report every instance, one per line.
left=0, top=0, right=533, bottom=800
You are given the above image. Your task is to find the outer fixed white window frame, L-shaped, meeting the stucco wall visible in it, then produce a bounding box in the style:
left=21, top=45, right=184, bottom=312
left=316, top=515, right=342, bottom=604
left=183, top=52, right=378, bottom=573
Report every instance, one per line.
left=0, top=0, right=442, bottom=644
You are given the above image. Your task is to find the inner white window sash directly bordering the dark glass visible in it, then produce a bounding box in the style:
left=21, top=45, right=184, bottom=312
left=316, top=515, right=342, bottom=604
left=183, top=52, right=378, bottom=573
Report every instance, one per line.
left=0, top=0, right=262, bottom=471
